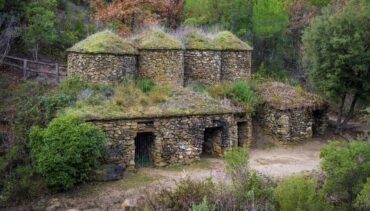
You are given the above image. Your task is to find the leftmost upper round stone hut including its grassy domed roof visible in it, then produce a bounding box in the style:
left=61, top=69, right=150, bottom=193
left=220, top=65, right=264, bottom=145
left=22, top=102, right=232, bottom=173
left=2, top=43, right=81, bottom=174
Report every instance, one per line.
left=67, top=31, right=138, bottom=84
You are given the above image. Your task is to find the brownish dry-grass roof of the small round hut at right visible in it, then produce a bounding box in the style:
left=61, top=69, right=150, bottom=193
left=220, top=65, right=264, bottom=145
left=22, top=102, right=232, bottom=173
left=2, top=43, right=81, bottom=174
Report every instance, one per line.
left=257, top=81, right=324, bottom=110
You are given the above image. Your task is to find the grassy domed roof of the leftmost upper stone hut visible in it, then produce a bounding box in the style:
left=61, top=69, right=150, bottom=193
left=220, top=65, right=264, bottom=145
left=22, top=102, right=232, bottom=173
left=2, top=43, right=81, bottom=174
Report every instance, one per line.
left=68, top=31, right=138, bottom=54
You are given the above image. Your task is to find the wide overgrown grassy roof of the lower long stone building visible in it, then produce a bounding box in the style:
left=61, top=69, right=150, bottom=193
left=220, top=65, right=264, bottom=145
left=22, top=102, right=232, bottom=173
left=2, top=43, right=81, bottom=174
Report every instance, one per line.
left=65, top=80, right=233, bottom=119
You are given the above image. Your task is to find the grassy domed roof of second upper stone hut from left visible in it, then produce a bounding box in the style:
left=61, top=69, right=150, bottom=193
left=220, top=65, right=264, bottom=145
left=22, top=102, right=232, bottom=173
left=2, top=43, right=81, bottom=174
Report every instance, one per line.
left=133, top=28, right=183, bottom=49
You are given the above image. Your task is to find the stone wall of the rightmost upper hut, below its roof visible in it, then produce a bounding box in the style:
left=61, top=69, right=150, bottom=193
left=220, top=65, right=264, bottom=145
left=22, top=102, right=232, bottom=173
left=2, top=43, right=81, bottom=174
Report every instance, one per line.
left=221, top=51, right=252, bottom=81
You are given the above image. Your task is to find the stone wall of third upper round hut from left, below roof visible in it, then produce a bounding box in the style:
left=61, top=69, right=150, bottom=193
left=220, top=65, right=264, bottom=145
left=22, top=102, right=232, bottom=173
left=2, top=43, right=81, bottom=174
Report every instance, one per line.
left=184, top=50, right=221, bottom=84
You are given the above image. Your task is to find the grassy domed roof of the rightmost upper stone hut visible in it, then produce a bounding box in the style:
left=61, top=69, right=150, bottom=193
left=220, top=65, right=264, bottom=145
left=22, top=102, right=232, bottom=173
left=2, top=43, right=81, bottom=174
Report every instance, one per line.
left=215, top=31, right=252, bottom=50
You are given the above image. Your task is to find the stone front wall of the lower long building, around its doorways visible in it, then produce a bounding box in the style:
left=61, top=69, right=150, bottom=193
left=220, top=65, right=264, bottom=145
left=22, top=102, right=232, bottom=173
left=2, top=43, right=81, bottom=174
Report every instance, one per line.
left=92, top=114, right=251, bottom=169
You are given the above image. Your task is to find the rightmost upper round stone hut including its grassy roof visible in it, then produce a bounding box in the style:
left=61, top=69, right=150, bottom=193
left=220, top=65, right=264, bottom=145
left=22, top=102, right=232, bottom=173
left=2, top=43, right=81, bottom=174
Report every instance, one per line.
left=215, top=31, right=253, bottom=81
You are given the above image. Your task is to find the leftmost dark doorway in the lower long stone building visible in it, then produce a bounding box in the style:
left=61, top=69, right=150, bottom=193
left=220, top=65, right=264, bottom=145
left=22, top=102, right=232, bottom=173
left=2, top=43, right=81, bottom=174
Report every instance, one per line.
left=135, top=132, right=155, bottom=168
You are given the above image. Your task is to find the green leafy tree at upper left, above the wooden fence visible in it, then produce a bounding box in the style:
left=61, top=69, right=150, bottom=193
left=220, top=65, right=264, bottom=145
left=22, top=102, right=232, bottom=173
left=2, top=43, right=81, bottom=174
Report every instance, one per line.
left=23, top=0, right=57, bottom=60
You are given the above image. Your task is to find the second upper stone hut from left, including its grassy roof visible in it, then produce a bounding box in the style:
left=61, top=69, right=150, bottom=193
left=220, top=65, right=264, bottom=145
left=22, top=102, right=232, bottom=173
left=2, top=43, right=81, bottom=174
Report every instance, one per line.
left=133, top=29, right=184, bottom=86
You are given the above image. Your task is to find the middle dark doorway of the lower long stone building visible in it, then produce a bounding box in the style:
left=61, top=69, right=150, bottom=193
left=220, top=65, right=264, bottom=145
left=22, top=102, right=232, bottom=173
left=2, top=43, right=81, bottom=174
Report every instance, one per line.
left=202, top=127, right=222, bottom=157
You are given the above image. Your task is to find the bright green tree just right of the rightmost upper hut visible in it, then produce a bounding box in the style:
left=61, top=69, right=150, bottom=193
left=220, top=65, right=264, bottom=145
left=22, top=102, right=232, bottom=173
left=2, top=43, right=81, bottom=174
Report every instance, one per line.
left=252, top=0, right=288, bottom=75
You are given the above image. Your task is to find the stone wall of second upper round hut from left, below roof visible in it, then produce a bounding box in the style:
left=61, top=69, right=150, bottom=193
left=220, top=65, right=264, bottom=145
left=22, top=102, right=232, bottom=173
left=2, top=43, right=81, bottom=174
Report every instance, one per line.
left=138, top=49, right=184, bottom=86
